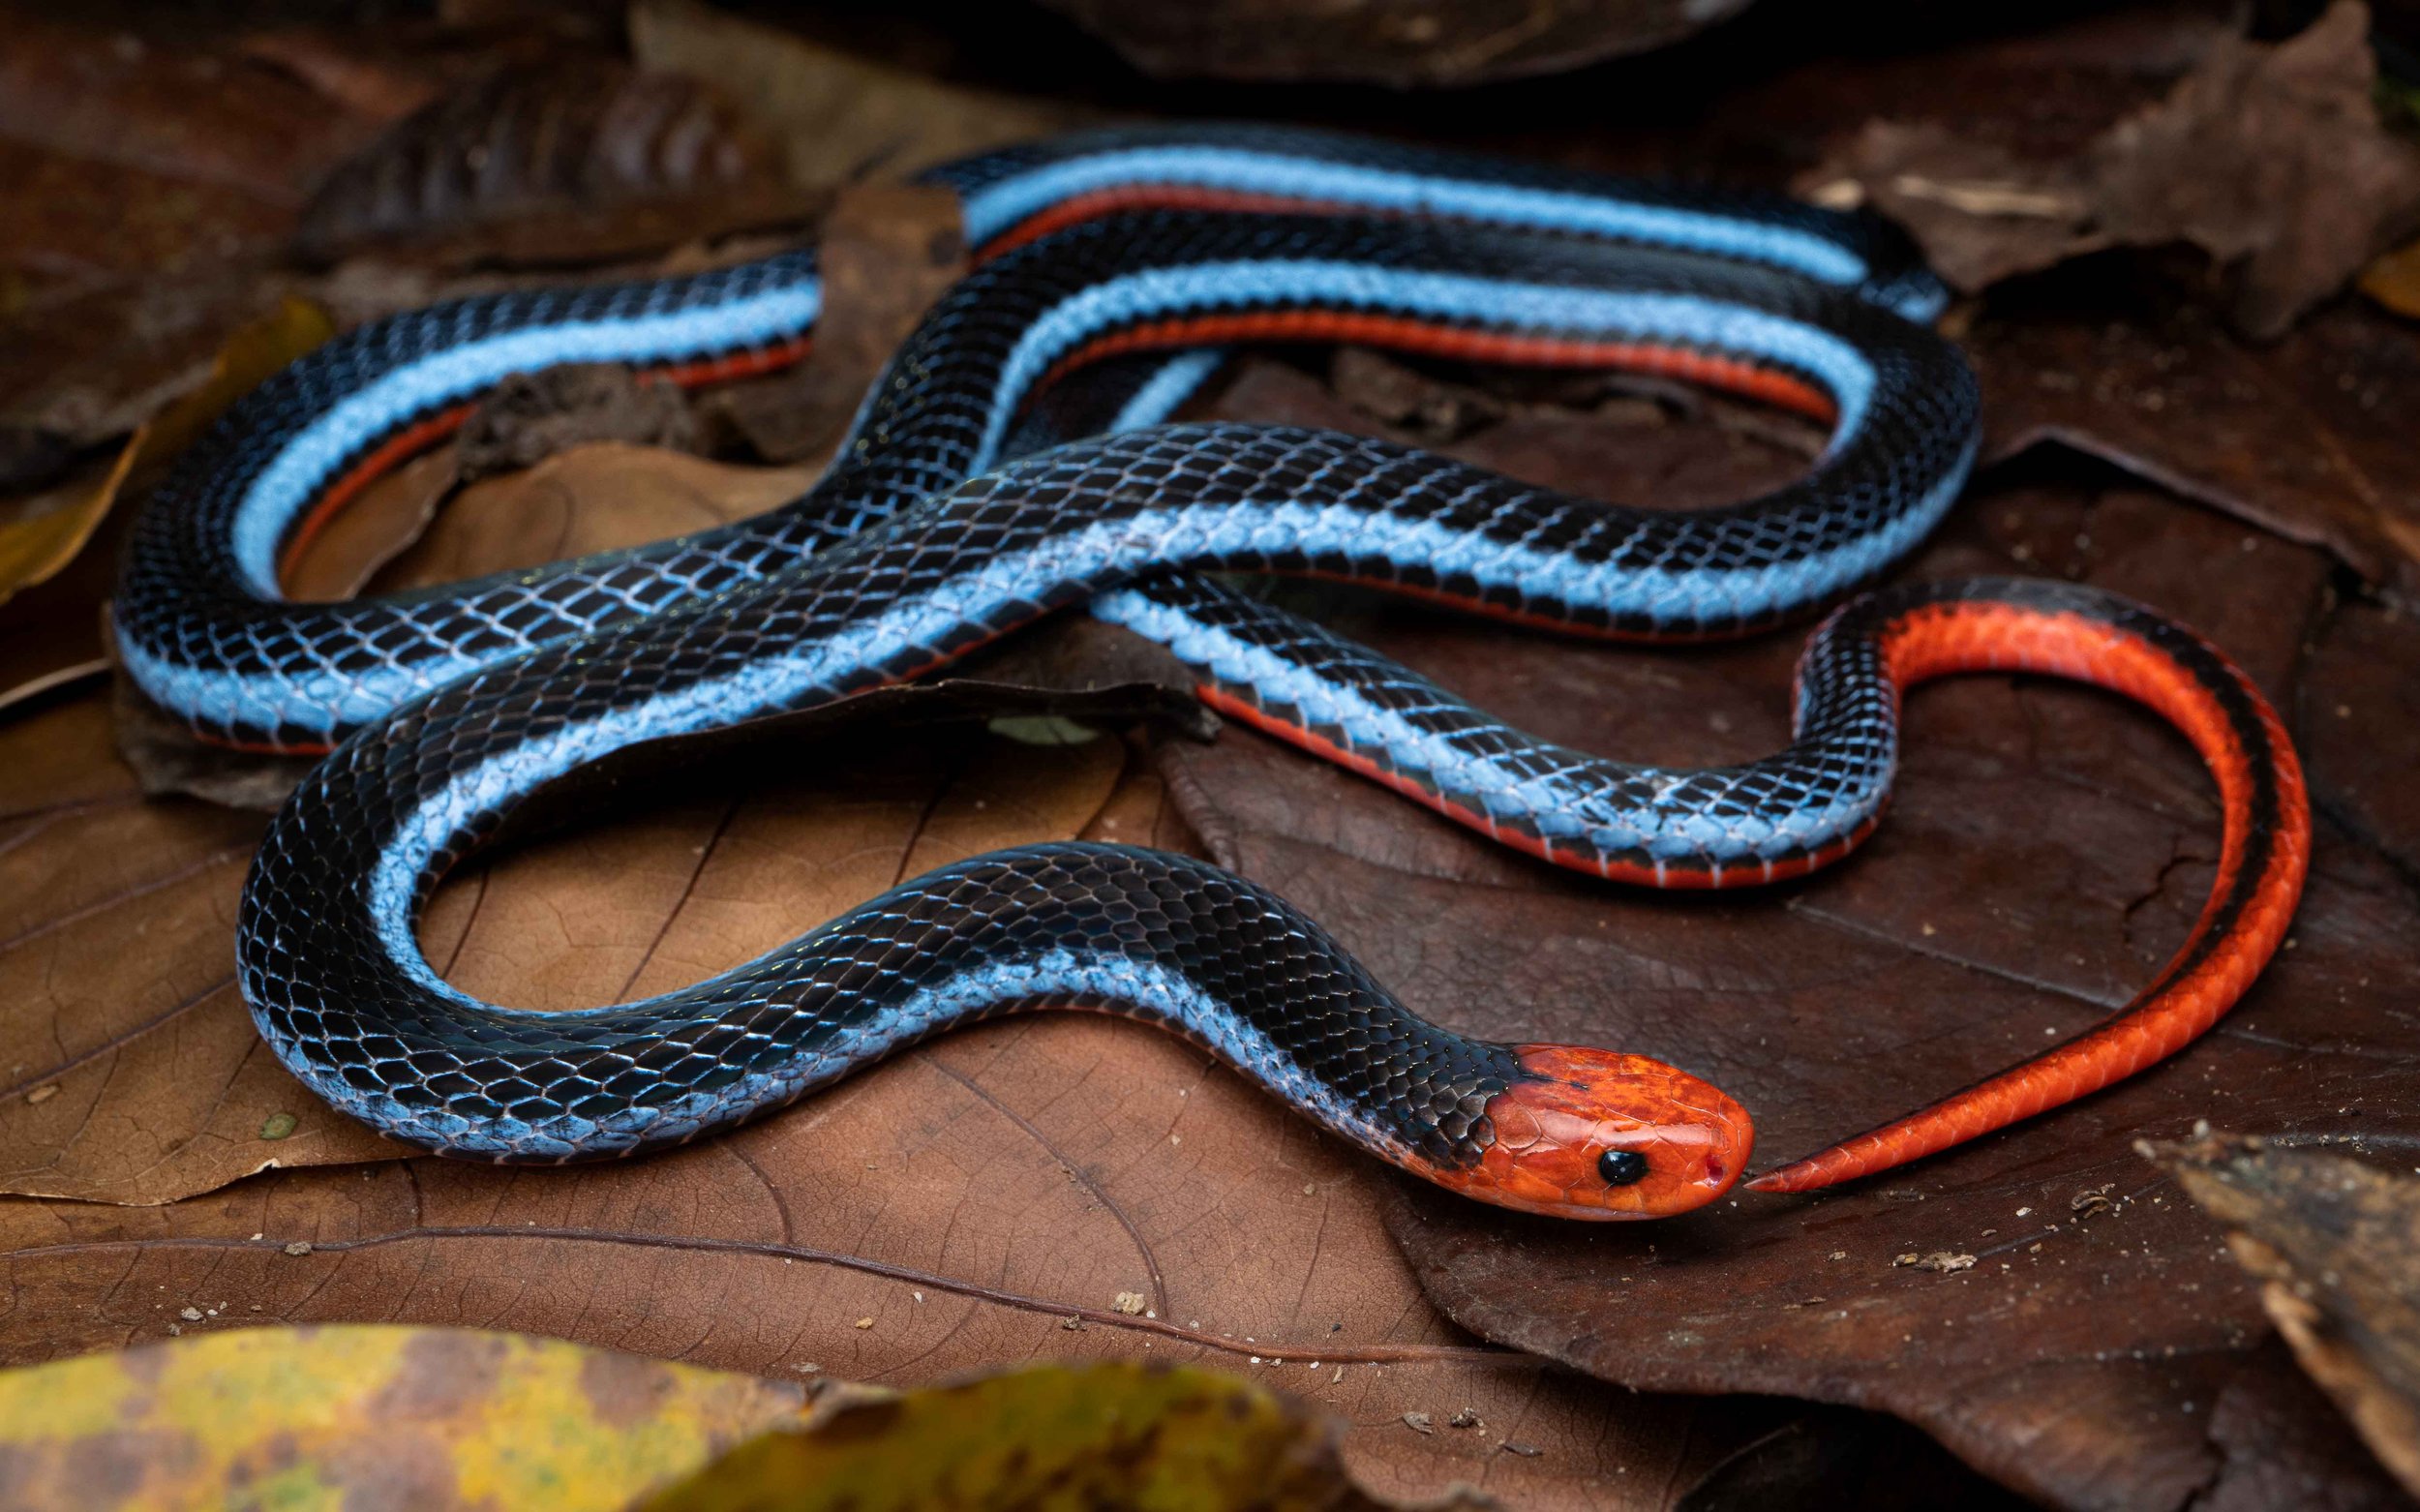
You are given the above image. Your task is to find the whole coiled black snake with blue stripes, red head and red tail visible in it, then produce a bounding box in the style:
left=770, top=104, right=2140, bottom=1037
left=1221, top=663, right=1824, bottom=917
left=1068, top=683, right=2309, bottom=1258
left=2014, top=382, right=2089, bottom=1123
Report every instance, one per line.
left=114, top=126, right=2309, bottom=1220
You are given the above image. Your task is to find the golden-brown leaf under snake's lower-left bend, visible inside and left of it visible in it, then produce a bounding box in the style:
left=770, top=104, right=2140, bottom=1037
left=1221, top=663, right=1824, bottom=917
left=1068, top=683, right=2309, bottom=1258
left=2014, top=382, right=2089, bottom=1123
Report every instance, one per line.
left=0, top=677, right=1152, bottom=1202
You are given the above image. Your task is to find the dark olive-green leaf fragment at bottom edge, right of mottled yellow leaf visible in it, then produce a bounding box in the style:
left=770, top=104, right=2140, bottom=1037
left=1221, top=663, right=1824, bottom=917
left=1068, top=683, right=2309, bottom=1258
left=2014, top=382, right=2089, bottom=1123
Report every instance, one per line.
left=647, top=1362, right=1404, bottom=1512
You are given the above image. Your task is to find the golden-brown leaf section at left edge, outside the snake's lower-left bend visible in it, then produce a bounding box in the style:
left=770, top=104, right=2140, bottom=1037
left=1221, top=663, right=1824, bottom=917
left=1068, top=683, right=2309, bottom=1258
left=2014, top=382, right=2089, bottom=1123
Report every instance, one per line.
left=0, top=697, right=392, bottom=1202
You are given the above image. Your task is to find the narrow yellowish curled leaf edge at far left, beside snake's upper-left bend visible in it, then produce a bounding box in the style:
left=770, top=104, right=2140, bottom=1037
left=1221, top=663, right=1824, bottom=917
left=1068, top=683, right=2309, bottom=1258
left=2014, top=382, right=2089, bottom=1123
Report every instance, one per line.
left=0, top=297, right=337, bottom=602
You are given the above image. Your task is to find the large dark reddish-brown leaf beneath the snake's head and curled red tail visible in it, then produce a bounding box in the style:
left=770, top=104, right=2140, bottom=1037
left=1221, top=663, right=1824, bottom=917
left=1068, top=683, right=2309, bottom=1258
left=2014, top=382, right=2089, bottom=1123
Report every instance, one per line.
left=1162, top=360, right=2420, bottom=1507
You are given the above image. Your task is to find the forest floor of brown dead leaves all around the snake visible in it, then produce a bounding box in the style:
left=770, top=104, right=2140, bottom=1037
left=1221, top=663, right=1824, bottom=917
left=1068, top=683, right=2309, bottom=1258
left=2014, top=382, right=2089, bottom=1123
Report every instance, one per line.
left=0, top=0, right=2420, bottom=1512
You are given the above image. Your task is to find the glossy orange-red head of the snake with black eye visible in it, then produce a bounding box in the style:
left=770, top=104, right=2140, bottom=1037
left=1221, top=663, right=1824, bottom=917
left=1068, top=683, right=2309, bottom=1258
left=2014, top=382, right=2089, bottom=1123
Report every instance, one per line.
left=1431, top=1045, right=1757, bottom=1220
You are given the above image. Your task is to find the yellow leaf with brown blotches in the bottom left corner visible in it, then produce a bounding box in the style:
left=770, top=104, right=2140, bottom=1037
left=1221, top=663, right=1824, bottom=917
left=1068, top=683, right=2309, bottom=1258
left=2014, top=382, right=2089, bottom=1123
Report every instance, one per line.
left=0, top=1325, right=806, bottom=1512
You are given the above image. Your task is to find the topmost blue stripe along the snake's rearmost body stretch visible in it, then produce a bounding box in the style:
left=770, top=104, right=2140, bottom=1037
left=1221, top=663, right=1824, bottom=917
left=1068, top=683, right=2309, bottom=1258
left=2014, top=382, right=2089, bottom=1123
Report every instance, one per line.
left=966, top=147, right=1866, bottom=287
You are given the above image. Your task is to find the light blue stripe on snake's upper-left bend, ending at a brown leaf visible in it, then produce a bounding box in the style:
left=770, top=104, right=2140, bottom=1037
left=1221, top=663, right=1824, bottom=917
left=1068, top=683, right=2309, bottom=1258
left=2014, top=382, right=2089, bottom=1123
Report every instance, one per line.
left=230, top=278, right=823, bottom=600
